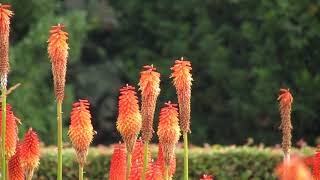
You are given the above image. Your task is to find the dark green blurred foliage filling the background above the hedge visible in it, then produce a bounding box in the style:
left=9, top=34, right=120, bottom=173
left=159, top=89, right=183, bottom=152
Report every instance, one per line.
left=3, top=0, right=320, bottom=144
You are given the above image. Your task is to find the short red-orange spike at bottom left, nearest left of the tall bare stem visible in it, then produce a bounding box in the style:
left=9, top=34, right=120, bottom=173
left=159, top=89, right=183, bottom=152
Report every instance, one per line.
left=21, top=128, right=40, bottom=179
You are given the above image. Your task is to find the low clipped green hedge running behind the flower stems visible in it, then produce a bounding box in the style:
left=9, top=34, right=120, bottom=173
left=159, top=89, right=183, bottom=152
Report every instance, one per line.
left=31, top=146, right=302, bottom=180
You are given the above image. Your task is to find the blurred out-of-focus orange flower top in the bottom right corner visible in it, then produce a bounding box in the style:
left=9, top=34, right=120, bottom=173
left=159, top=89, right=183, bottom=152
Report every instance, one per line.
left=275, top=157, right=312, bottom=180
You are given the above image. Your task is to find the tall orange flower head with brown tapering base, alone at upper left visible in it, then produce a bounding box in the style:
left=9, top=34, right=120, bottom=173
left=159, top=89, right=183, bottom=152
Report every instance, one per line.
left=48, top=24, right=69, bottom=101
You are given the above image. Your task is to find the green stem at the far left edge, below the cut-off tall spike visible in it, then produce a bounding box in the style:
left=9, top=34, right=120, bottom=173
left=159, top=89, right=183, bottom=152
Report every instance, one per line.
left=1, top=87, right=7, bottom=180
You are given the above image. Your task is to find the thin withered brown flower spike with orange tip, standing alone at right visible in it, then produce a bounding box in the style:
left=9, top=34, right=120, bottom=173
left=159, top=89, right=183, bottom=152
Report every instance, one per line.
left=278, top=89, right=293, bottom=159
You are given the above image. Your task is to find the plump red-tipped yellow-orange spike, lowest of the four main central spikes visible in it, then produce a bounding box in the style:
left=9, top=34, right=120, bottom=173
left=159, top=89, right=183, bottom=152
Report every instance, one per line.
left=157, top=101, right=181, bottom=165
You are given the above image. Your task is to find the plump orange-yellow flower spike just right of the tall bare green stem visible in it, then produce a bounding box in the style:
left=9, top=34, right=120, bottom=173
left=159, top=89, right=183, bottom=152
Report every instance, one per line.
left=68, top=99, right=95, bottom=167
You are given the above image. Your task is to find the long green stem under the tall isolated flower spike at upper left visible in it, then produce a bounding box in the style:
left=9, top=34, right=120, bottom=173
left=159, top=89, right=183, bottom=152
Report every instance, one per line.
left=57, top=101, right=62, bottom=180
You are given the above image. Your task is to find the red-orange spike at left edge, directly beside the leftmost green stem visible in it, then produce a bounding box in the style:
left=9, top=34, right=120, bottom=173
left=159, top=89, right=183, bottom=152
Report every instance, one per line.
left=0, top=104, right=18, bottom=160
